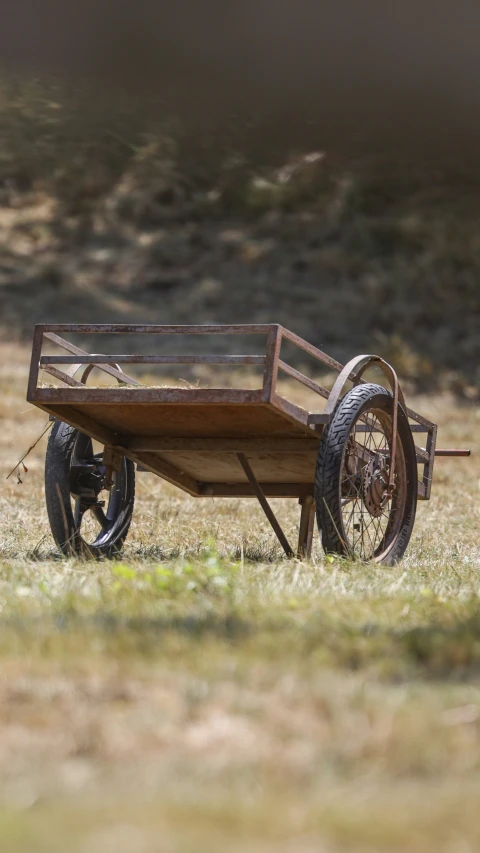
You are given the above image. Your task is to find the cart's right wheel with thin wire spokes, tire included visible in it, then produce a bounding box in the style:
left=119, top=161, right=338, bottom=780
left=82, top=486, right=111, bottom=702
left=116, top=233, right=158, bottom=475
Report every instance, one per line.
left=315, top=383, right=418, bottom=565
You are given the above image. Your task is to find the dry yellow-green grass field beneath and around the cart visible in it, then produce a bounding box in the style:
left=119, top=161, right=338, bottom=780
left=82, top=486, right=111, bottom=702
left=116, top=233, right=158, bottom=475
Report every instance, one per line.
left=0, top=344, right=480, bottom=853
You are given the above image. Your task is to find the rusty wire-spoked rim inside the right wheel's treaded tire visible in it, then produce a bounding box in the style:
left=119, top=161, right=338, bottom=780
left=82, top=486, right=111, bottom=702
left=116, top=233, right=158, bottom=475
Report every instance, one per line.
left=338, top=409, right=407, bottom=562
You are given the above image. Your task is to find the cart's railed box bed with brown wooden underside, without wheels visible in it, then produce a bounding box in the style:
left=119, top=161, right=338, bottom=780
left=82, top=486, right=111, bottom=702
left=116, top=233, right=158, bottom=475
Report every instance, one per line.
left=28, top=325, right=436, bottom=498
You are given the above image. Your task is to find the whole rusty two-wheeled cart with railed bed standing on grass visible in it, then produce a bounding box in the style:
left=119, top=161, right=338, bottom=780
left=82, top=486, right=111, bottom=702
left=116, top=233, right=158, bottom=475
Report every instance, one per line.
left=27, top=324, right=469, bottom=564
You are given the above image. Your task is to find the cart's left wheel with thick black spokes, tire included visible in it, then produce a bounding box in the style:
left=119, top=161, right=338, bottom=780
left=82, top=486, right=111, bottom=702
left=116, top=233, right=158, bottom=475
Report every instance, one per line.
left=45, top=421, right=135, bottom=557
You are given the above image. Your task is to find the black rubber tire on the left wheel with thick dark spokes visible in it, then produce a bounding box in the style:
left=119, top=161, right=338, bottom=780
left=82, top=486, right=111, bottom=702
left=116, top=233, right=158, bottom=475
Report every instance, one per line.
left=45, top=421, right=135, bottom=557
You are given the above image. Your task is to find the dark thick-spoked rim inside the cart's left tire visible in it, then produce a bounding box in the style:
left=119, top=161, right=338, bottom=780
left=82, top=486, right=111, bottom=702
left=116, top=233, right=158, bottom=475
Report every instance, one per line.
left=70, top=433, right=126, bottom=549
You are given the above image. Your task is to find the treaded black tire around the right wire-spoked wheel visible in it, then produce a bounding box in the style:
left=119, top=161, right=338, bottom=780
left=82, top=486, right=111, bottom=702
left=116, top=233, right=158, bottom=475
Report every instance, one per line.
left=315, top=382, right=418, bottom=566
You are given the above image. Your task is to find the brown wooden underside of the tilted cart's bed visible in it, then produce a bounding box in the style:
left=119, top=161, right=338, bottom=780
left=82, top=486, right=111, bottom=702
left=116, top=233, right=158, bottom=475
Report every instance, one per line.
left=30, top=388, right=319, bottom=497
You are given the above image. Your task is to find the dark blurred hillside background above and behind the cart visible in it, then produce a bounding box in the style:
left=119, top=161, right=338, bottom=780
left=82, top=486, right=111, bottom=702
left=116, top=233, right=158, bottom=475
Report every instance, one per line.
left=0, top=0, right=480, bottom=392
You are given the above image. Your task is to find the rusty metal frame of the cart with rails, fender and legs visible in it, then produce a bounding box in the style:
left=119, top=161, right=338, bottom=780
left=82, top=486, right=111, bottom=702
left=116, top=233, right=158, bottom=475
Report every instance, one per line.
left=27, top=324, right=468, bottom=557
